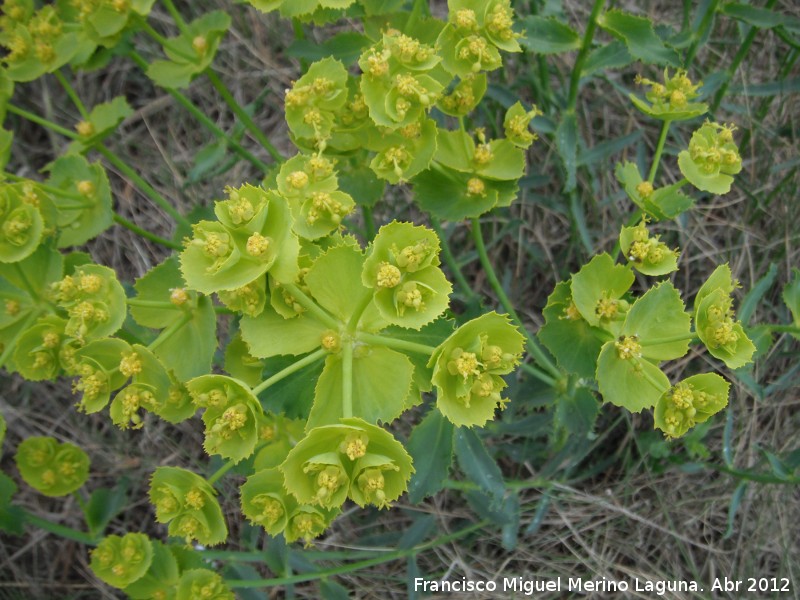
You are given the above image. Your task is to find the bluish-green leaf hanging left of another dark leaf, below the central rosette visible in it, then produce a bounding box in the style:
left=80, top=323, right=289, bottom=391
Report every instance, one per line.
left=406, top=409, right=454, bottom=504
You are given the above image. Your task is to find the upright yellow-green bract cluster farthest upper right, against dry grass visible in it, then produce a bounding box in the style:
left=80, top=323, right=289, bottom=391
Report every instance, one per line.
left=678, top=122, right=742, bottom=194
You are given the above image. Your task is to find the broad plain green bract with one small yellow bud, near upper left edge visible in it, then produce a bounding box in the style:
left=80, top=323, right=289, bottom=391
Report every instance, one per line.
left=46, top=155, right=114, bottom=248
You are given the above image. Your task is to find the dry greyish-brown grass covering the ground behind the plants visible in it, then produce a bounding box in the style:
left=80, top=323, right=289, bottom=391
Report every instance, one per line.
left=0, top=1, right=800, bottom=599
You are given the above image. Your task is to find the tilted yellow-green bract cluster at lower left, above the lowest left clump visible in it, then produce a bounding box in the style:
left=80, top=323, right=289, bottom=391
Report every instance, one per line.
left=150, top=467, right=228, bottom=546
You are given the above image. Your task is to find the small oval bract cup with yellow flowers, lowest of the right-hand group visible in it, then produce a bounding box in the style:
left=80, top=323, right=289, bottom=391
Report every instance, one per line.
left=653, top=373, right=730, bottom=438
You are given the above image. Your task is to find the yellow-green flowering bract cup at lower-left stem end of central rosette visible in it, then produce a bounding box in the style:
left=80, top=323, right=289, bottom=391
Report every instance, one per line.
left=186, top=375, right=263, bottom=462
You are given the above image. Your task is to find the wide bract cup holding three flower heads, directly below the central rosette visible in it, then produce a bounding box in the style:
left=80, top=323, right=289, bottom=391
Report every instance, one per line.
left=280, top=418, right=414, bottom=508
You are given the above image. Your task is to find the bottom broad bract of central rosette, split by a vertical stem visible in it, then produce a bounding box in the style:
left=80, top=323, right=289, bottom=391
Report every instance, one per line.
left=306, top=346, right=414, bottom=430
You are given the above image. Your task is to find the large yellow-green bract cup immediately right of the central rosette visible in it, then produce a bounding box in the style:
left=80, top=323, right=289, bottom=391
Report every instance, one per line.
left=428, top=312, right=524, bottom=427
